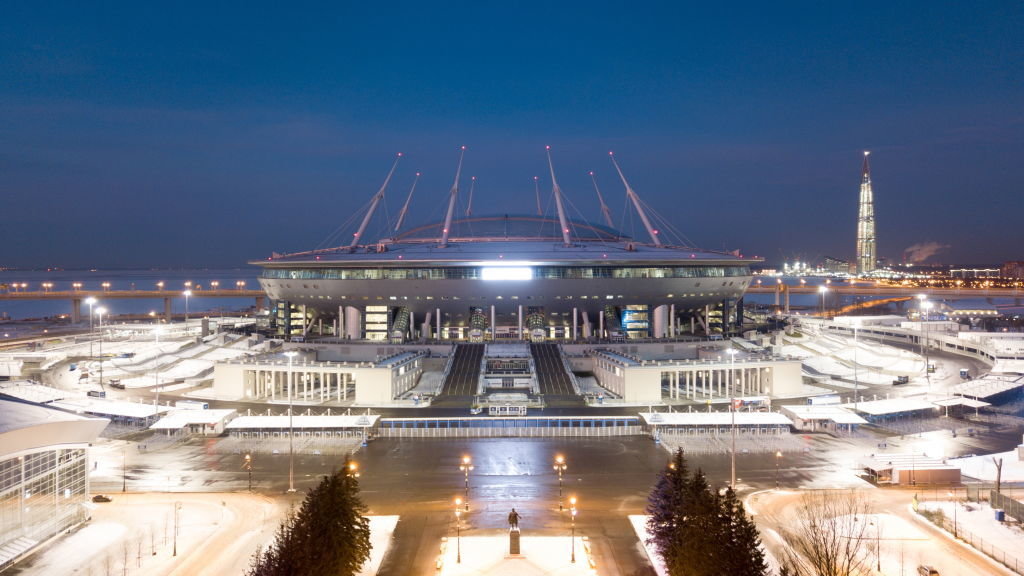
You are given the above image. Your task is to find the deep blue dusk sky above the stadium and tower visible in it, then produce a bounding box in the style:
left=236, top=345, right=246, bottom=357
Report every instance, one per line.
left=0, top=1, right=1024, bottom=268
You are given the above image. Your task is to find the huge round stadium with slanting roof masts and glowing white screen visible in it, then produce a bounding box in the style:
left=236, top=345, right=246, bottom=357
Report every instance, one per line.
left=252, top=148, right=760, bottom=341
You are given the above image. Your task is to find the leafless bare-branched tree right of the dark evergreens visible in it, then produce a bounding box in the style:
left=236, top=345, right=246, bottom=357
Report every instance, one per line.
left=781, top=491, right=877, bottom=576
